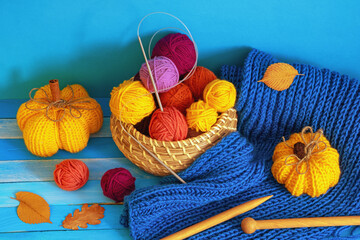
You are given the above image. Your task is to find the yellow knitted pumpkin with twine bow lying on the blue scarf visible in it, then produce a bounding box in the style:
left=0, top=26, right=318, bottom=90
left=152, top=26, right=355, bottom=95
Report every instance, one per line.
left=271, top=127, right=341, bottom=197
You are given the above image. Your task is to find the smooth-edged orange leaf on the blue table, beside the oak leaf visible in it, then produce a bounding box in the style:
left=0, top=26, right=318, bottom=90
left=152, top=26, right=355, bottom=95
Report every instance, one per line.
left=12, top=192, right=52, bottom=224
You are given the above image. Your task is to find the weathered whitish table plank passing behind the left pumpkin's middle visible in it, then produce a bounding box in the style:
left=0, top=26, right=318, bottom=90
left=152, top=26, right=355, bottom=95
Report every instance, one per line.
left=0, top=117, right=111, bottom=139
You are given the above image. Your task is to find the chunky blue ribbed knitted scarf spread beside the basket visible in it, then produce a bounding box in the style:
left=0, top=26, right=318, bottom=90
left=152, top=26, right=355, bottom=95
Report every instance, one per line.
left=122, top=50, right=360, bottom=240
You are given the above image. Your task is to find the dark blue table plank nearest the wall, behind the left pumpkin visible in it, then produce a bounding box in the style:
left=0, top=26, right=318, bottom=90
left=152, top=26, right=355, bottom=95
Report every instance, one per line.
left=0, top=97, right=111, bottom=118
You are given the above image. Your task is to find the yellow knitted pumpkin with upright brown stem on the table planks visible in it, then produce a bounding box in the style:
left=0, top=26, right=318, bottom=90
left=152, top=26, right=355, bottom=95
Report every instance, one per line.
left=16, top=80, right=103, bottom=157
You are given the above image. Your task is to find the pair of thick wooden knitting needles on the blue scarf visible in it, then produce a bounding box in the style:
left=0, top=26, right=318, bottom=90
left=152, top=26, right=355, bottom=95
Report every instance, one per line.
left=161, top=195, right=360, bottom=240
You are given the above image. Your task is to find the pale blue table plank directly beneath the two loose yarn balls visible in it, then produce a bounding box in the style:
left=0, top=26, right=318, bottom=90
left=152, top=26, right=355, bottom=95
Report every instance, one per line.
left=0, top=177, right=160, bottom=208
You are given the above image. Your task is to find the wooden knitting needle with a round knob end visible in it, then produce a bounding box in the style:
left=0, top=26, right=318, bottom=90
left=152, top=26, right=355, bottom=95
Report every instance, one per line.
left=241, top=216, right=360, bottom=234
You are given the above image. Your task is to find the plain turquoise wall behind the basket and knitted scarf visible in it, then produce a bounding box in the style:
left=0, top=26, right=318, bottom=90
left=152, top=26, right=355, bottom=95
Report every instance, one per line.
left=0, top=0, right=360, bottom=99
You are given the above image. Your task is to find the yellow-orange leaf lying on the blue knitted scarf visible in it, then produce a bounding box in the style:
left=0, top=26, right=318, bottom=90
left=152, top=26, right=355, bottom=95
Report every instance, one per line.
left=258, top=63, right=304, bottom=91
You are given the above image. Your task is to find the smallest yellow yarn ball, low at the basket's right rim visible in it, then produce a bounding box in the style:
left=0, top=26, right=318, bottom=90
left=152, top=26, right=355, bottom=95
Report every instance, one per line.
left=186, top=100, right=218, bottom=132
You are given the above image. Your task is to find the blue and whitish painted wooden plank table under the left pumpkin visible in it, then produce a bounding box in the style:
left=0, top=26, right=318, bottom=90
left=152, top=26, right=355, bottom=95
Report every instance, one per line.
left=0, top=98, right=159, bottom=240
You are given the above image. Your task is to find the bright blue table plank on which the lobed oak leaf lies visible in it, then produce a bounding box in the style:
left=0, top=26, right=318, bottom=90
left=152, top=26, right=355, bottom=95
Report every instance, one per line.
left=0, top=205, right=125, bottom=233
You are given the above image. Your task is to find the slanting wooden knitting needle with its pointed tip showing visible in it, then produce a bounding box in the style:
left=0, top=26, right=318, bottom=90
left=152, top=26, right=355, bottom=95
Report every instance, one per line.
left=161, top=195, right=273, bottom=240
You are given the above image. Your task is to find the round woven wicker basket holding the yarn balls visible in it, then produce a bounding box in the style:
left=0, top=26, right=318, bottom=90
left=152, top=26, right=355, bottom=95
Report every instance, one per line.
left=110, top=108, right=237, bottom=176
